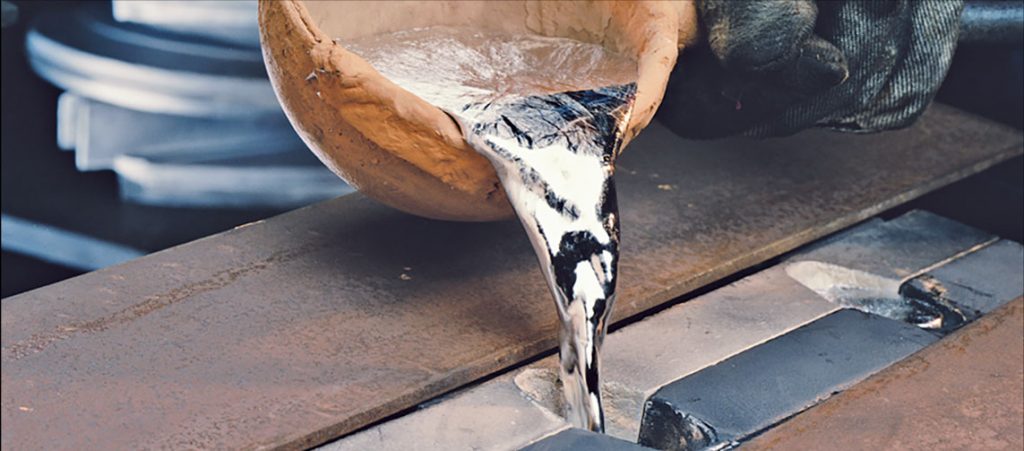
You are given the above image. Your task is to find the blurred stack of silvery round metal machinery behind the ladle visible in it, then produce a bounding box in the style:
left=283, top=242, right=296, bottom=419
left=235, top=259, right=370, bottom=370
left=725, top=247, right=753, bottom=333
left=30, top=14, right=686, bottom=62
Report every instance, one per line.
left=26, top=0, right=351, bottom=208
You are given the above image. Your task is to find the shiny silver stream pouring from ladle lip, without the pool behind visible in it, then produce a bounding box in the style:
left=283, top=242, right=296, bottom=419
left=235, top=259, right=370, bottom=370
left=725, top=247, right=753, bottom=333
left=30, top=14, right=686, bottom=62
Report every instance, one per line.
left=458, top=83, right=636, bottom=432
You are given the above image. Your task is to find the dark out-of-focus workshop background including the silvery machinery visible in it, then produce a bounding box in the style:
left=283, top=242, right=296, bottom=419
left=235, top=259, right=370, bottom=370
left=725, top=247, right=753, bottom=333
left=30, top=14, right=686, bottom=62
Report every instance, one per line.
left=0, top=0, right=1024, bottom=297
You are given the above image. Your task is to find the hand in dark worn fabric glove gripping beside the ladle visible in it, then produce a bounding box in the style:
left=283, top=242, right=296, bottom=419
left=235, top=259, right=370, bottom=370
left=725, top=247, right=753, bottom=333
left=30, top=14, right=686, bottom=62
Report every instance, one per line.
left=659, top=0, right=964, bottom=138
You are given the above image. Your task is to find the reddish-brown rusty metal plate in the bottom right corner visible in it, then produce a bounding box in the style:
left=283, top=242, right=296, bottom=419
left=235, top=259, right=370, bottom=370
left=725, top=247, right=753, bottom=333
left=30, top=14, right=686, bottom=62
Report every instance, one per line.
left=742, top=298, right=1024, bottom=450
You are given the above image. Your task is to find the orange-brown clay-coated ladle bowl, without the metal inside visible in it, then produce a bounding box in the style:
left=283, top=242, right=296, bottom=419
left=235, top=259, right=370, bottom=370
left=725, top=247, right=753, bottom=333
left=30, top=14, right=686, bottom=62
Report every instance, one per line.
left=259, top=0, right=697, bottom=220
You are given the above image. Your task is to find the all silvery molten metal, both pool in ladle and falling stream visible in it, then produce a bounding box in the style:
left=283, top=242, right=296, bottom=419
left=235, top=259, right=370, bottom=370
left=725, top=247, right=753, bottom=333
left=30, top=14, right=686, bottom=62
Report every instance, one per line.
left=345, top=27, right=636, bottom=432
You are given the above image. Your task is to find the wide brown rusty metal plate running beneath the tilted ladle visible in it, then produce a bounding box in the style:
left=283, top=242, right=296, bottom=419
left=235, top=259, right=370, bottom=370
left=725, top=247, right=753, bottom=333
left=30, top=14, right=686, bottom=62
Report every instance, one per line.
left=0, top=106, right=1022, bottom=449
